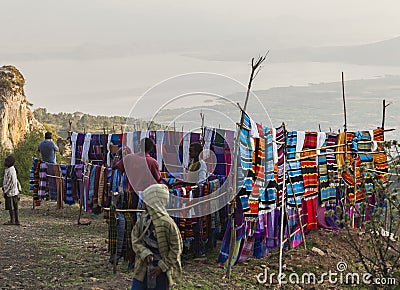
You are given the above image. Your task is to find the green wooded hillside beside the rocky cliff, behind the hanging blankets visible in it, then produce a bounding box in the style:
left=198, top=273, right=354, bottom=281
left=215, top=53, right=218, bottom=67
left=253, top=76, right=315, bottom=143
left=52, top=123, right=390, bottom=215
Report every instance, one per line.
left=33, top=108, right=163, bottom=138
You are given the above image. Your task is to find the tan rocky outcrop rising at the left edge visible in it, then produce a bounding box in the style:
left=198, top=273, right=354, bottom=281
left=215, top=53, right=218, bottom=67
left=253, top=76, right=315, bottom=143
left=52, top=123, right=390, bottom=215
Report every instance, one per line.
left=0, top=66, right=44, bottom=149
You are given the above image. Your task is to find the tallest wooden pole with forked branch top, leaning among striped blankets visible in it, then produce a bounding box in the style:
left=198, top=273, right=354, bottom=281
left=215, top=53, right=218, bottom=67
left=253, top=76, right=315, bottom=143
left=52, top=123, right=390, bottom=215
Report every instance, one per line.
left=226, top=52, right=268, bottom=279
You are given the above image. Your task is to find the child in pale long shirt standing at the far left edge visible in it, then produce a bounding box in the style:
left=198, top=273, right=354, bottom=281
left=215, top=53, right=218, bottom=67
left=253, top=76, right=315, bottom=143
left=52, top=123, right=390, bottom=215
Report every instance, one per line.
left=3, top=155, right=21, bottom=226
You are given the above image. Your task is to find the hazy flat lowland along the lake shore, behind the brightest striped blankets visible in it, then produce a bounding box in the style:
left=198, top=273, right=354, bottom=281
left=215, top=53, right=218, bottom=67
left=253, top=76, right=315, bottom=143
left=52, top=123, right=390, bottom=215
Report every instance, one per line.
left=157, top=76, right=400, bottom=140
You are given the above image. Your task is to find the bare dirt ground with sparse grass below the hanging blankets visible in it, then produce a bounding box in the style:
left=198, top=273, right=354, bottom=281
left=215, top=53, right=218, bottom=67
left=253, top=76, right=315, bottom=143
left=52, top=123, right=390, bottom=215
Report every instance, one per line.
left=0, top=196, right=388, bottom=290
